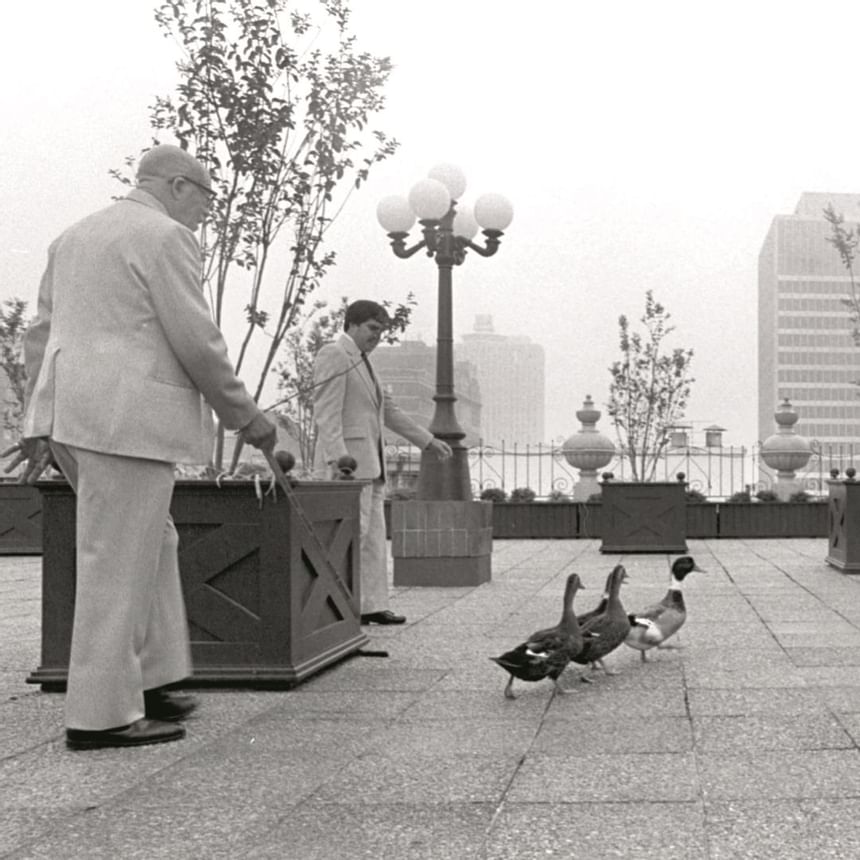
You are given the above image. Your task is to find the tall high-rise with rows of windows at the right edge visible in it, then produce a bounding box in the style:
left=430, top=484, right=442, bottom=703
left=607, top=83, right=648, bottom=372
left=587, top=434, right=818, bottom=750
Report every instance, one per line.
left=758, top=193, right=860, bottom=445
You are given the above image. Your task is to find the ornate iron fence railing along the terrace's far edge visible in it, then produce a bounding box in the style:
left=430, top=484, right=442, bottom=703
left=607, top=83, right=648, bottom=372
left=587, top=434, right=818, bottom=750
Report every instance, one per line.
left=386, top=442, right=860, bottom=501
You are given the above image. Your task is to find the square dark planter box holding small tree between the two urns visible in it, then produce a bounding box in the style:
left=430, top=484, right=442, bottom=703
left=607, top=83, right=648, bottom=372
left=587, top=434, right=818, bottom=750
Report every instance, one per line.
left=600, top=481, right=687, bottom=553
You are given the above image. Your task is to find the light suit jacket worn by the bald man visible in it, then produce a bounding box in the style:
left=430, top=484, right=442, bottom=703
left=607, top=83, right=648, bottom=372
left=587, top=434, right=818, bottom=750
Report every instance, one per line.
left=24, top=189, right=258, bottom=463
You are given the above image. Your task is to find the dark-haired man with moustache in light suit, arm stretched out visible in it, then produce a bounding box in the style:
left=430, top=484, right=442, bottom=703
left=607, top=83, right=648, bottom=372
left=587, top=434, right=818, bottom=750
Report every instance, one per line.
left=314, top=299, right=451, bottom=624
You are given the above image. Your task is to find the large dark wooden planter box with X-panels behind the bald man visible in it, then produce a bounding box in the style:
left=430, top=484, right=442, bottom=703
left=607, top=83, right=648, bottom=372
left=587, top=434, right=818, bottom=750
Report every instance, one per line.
left=27, top=481, right=368, bottom=689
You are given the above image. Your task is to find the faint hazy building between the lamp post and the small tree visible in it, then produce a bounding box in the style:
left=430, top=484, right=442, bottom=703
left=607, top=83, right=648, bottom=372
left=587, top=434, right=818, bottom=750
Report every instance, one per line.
left=454, top=314, right=546, bottom=446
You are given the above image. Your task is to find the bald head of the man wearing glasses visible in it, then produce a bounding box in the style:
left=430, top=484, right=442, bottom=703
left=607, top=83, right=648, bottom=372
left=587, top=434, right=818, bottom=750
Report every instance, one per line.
left=137, top=143, right=214, bottom=230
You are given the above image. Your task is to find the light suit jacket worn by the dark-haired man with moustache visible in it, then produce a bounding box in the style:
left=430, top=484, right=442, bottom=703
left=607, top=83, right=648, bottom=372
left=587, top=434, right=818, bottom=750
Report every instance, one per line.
left=314, top=334, right=433, bottom=479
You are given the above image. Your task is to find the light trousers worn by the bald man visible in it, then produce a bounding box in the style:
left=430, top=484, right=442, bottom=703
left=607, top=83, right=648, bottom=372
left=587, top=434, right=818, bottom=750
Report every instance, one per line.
left=51, top=443, right=191, bottom=731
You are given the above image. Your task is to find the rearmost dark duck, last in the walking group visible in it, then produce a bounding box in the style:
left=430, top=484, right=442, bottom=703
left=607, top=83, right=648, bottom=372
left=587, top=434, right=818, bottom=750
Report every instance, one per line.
left=490, top=573, right=583, bottom=699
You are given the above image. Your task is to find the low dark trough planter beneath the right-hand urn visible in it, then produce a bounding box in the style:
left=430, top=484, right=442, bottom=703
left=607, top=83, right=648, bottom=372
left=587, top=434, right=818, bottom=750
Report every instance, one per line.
left=720, top=502, right=827, bottom=538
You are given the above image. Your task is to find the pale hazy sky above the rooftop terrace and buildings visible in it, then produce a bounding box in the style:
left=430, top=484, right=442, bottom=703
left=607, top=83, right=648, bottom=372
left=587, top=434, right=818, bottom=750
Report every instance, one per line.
left=0, top=5, right=860, bottom=444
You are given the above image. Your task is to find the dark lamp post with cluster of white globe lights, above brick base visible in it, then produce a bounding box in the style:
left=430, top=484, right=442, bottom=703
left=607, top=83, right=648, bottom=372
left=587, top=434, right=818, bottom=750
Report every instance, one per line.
left=376, top=164, right=513, bottom=501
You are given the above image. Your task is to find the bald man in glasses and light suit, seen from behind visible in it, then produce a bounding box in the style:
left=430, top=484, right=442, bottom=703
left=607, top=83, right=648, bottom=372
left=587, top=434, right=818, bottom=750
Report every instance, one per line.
left=10, top=145, right=276, bottom=749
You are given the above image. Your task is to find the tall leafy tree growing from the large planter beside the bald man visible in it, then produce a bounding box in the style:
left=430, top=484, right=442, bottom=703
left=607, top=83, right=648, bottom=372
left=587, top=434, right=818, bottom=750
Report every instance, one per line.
left=113, top=0, right=397, bottom=471
